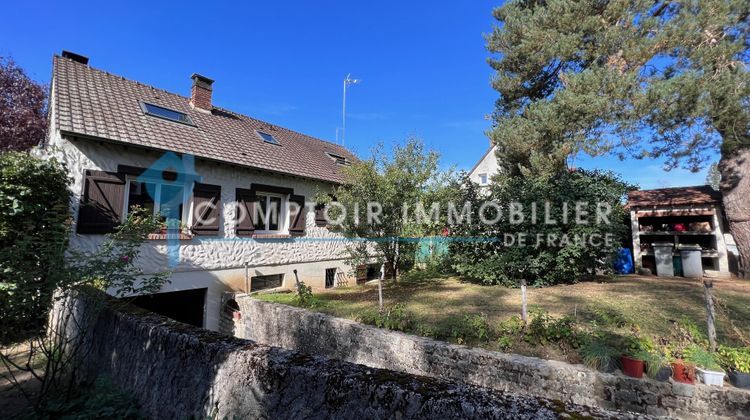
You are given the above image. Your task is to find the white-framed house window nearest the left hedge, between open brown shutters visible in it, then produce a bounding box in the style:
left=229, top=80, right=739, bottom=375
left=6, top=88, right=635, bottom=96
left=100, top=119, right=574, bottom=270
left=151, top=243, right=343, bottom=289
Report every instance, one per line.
left=123, top=177, right=190, bottom=222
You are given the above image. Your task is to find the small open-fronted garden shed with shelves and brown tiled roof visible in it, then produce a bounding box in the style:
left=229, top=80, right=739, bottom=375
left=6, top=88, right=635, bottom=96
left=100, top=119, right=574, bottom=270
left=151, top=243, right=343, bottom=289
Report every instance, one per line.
left=628, top=185, right=738, bottom=277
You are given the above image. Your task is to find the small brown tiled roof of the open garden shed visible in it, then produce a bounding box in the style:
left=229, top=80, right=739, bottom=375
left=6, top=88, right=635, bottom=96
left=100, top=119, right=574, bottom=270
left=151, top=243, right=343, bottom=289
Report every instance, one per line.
left=628, top=185, right=721, bottom=207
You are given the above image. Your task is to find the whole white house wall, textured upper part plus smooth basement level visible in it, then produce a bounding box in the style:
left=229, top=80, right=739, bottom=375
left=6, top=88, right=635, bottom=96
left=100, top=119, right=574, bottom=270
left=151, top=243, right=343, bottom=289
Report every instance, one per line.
left=44, top=132, right=354, bottom=329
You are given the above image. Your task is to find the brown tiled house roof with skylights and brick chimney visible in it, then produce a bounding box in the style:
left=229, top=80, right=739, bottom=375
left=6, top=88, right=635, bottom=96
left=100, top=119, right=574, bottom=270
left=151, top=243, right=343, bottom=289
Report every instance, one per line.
left=53, top=56, right=355, bottom=183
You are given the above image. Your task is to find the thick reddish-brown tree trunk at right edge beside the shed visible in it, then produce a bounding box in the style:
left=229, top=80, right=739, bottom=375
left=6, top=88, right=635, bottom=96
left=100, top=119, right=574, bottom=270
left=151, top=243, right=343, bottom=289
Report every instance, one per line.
left=719, top=148, right=750, bottom=278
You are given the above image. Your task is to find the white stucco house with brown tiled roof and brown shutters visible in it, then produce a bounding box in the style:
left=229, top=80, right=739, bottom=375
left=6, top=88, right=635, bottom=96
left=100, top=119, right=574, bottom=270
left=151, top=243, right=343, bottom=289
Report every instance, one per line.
left=42, top=52, right=356, bottom=330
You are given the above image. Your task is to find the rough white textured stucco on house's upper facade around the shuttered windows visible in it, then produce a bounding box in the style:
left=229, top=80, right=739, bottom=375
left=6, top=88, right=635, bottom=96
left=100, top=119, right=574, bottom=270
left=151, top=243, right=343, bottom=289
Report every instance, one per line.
left=49, top=132, right=348, bottom=276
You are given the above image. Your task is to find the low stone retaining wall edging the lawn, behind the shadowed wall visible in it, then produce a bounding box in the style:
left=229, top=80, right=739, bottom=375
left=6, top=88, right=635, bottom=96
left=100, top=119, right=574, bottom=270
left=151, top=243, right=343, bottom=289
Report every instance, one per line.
left=236, top=295, right=750, bottom=418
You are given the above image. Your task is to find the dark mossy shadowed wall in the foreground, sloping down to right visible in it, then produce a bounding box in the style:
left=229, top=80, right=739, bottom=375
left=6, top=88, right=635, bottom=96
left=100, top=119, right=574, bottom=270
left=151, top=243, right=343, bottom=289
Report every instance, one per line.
left=53, top=296, right=633, bottom=419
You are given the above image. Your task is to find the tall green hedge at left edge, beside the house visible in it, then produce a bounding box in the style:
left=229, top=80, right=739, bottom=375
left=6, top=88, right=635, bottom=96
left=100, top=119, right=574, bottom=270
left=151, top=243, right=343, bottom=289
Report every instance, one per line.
left=0, top=152, right=70, bottom=344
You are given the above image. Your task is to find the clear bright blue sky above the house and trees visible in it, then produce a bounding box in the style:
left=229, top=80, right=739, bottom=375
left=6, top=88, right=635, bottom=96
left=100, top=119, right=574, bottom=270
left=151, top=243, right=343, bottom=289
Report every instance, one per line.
left=0, top=0, right=718, bottom=188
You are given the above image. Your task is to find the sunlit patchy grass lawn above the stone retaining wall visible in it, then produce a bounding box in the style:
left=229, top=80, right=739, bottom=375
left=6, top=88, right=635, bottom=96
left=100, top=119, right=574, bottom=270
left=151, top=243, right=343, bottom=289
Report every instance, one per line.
left=256, top=275, right=750, bottom=362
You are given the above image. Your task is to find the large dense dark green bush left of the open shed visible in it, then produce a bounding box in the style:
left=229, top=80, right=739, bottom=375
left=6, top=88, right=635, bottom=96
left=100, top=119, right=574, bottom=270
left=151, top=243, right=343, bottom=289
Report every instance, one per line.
left=450, top=170, right=632, bottom=286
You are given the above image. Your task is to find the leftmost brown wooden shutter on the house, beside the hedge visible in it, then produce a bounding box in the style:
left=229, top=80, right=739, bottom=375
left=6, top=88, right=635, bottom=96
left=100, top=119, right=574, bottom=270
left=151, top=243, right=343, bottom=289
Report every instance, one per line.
left=76, top=169, right=125, bottom=234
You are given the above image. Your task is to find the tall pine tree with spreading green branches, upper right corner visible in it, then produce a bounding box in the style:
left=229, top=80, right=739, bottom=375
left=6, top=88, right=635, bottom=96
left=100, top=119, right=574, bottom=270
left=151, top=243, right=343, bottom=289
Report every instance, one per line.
left=487, top=0, right=750, bottom=278
